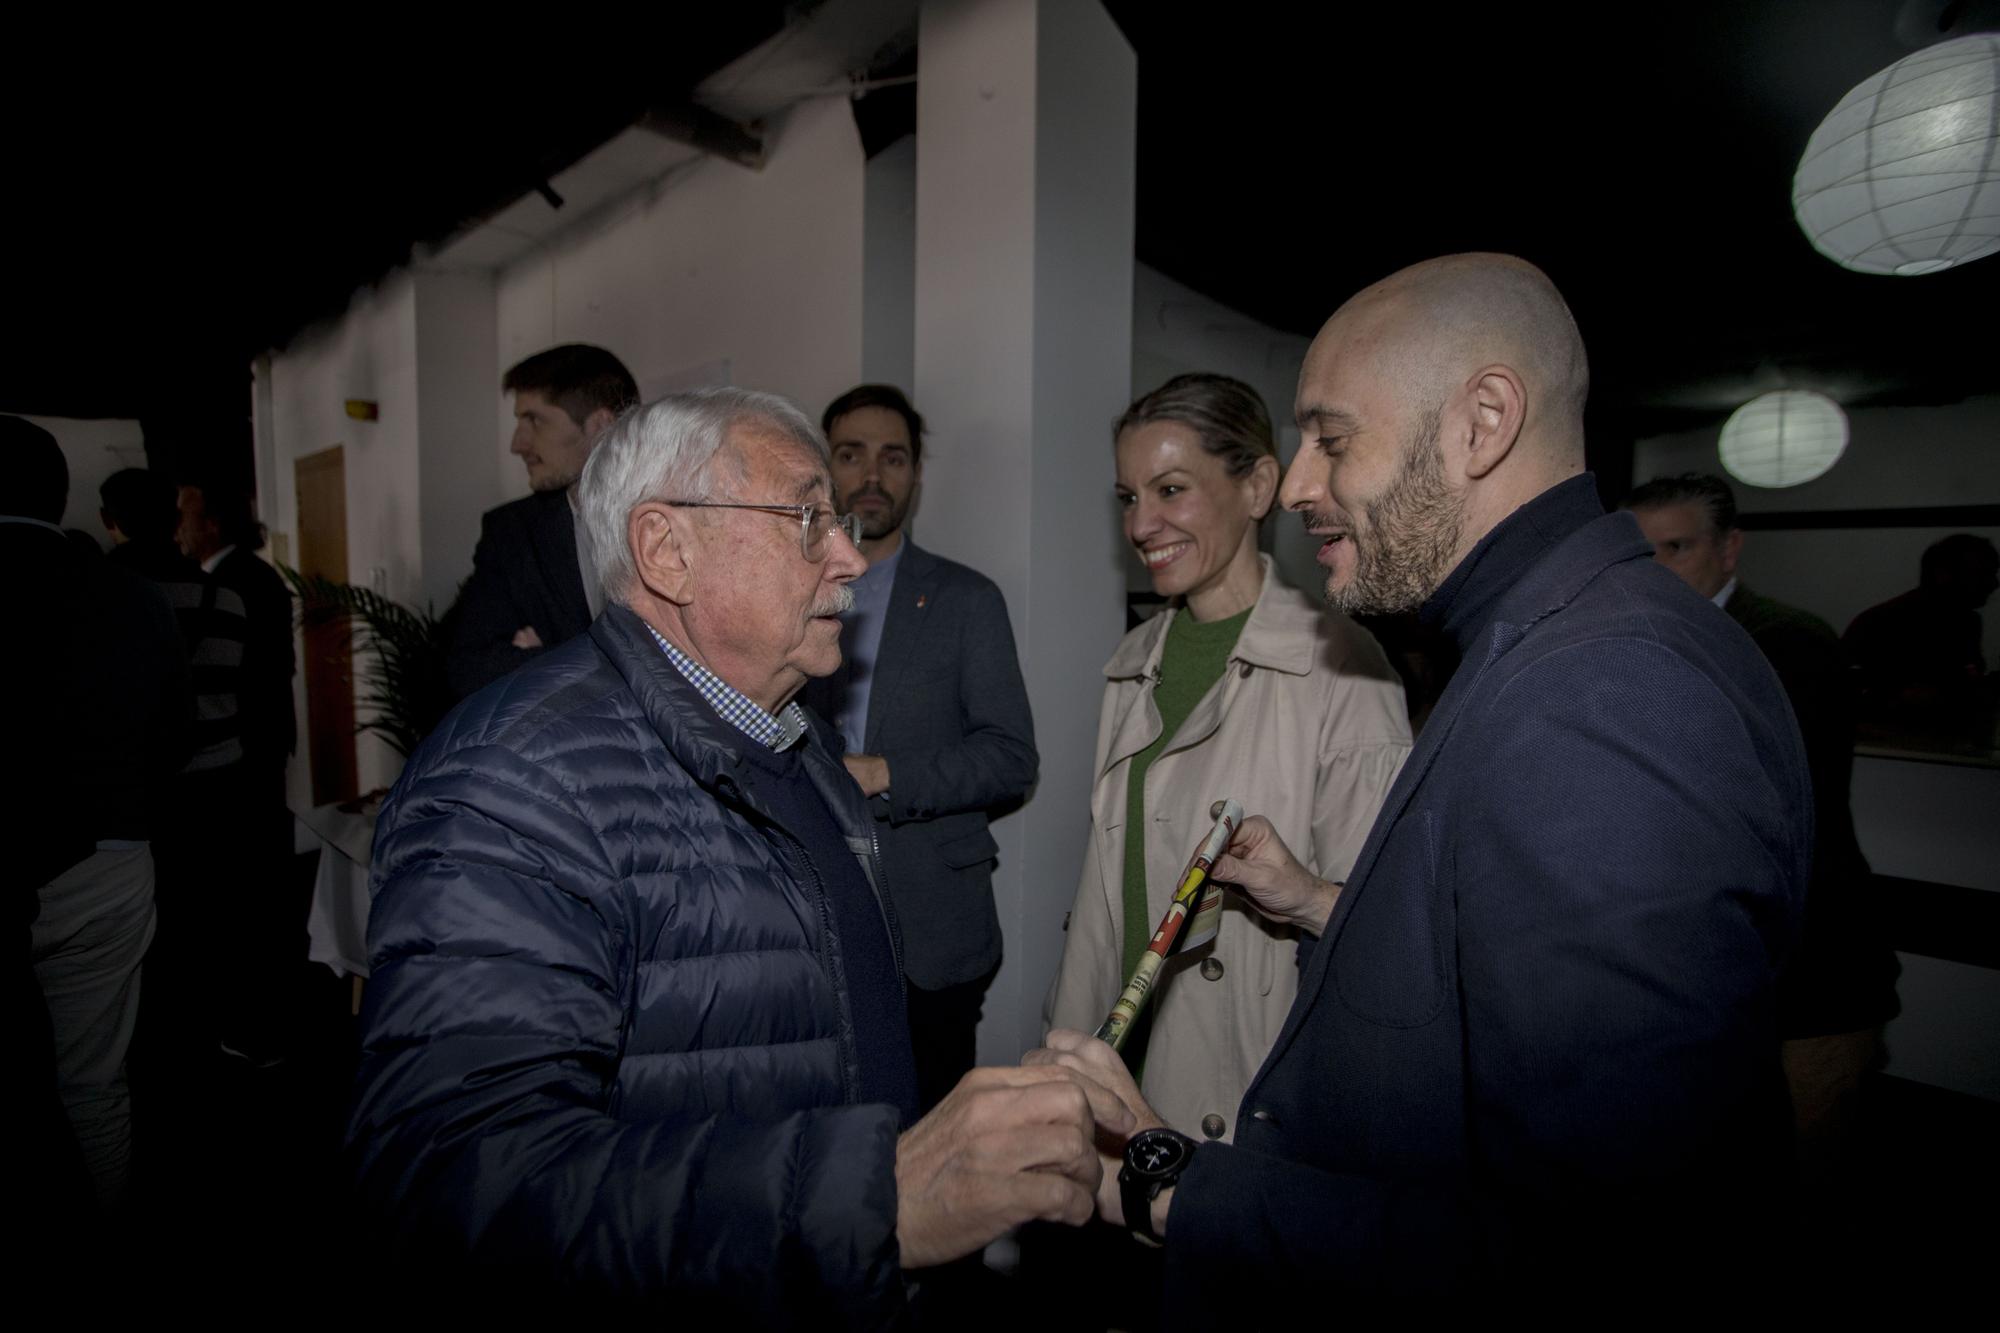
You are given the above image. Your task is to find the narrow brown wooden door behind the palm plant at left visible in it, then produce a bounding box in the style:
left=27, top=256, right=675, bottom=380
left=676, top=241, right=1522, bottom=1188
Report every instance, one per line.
left=292, top=444, right=360, bottom=805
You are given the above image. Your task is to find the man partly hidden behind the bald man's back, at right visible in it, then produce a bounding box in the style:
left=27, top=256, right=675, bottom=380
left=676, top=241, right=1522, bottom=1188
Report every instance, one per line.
left=1624, top=472, right=1898, bottom=1175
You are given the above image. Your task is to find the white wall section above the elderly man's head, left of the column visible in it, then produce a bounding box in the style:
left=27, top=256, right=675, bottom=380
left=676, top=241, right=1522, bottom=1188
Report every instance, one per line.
left=488, top=98, right=864, bottom=492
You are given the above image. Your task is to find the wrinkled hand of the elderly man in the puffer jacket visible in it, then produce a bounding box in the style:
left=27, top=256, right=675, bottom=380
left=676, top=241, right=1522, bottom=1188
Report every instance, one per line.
left=896, top=1067, right=1132, bottom=1269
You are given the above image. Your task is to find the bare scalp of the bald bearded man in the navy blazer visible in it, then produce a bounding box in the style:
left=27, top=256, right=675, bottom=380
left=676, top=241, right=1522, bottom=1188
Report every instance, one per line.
left=1314, top=254, right=1590, bottom=466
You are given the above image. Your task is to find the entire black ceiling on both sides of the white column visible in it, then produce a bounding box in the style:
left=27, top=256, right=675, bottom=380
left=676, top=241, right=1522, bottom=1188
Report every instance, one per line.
left=0, top=0, right=2000, bottom=462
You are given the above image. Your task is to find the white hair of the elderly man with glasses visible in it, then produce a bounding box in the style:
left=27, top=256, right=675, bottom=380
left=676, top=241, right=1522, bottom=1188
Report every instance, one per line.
left=576, top=378, right=830, bottom=602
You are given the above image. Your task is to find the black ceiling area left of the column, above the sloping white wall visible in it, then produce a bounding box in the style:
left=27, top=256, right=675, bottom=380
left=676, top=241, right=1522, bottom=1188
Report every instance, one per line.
left=0, top=10, right=790, bottom=434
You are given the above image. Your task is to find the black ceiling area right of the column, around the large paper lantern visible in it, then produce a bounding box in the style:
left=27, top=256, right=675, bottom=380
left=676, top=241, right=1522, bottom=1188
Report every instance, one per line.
left=1108, top=0, right=2000, bottom=436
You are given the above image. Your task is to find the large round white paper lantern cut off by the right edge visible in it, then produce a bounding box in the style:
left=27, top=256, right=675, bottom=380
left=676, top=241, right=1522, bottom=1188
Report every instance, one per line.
left=1792, top=32, right=2000, bottom=276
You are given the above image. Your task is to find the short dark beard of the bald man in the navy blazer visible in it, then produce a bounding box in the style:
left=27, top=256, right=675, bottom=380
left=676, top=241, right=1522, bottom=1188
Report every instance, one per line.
left=1326, top=408, right=1466, bottom=616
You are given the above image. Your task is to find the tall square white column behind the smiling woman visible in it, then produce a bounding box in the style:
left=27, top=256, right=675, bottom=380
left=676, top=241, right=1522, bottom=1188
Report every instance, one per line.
left=914, top=0, right=1138, bottom=1063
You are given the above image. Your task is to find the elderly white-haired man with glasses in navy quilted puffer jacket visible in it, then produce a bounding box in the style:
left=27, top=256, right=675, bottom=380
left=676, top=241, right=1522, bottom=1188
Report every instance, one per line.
left=348, top=388, right=1130, bottom=1327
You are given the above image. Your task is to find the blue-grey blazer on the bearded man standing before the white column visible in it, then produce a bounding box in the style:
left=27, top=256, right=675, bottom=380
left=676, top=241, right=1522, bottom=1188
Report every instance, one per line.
left=800, top=536, right=1040, bottom=991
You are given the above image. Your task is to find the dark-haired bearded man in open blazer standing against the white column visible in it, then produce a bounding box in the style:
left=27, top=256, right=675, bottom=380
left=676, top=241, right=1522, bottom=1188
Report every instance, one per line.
left=802, top=384, right=1038, bottom=1111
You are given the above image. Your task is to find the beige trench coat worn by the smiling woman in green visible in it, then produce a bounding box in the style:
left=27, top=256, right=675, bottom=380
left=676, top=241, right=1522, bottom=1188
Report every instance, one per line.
left=1044, top=556, right=1410, bottom=1139
